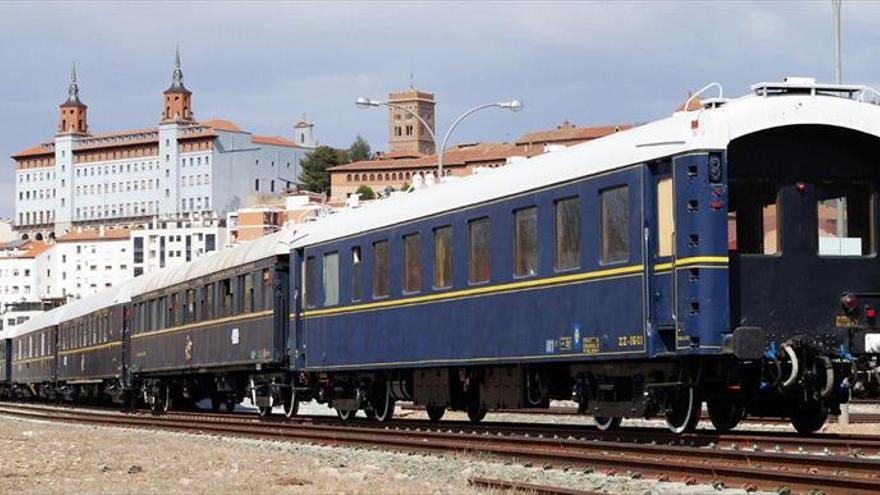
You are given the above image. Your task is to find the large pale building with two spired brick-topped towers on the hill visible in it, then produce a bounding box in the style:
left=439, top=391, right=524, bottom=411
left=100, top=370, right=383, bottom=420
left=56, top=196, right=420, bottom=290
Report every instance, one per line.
left=12, top=56, right=315, bottom=239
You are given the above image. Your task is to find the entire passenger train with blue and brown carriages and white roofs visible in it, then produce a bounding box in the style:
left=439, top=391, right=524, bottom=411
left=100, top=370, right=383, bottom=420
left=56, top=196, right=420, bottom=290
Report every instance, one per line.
left=0, top=78, right=880, bottom=434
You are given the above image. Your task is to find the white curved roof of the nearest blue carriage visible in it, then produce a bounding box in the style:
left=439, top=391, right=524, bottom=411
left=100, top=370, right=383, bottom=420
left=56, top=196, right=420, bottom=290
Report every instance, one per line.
left=294, top=82, right=880, bottom=247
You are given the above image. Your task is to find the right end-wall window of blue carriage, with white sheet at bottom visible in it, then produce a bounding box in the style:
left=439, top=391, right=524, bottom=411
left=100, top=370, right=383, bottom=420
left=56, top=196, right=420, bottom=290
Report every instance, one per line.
left=816, top=183, right=874, bottom=256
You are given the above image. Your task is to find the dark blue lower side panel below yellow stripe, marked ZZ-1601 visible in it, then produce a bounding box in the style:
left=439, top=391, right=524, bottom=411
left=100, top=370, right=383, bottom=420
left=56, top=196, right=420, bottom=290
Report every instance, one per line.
left=305, top=274, right=644, bottom=368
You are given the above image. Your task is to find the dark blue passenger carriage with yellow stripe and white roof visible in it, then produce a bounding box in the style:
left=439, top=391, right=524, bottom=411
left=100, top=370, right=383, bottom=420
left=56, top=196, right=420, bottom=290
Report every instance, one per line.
left=292, top=80, right=880, bottom=432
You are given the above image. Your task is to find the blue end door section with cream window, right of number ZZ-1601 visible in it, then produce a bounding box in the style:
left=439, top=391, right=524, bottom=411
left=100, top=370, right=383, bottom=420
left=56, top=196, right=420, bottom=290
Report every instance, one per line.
left=651, top=153, right=729, bottom=354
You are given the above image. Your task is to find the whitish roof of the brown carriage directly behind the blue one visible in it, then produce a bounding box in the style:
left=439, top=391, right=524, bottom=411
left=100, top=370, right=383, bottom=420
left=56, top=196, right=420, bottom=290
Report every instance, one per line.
left=132, top=227, right=296, bottom=297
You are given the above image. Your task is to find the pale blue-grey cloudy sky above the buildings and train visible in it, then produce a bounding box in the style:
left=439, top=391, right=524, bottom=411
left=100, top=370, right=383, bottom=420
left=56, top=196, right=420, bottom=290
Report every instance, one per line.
left=0, top=0, right=880, bottom=217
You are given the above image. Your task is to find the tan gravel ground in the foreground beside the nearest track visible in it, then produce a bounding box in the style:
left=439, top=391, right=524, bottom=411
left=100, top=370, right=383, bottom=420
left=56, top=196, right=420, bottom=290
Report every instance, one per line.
left=0, top=410, right=768, bottom=495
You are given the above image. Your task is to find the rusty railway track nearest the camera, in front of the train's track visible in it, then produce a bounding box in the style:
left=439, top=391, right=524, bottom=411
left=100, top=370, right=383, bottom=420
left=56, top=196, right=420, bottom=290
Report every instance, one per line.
left=0, top=406, right=880, bottom=494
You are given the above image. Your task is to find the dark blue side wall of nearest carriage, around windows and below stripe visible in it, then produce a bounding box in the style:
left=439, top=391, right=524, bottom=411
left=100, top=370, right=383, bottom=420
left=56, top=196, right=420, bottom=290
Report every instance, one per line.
left=301, top=167, right=645, bottom=368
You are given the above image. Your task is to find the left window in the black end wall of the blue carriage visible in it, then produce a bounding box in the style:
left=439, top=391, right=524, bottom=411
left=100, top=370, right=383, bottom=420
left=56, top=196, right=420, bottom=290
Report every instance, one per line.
left=727, top=178, right=780, bottom=255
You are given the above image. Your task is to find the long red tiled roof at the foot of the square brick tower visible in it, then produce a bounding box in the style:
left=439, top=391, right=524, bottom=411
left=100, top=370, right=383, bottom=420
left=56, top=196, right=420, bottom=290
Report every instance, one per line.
left=330, top=143, right=544, bottom=172
